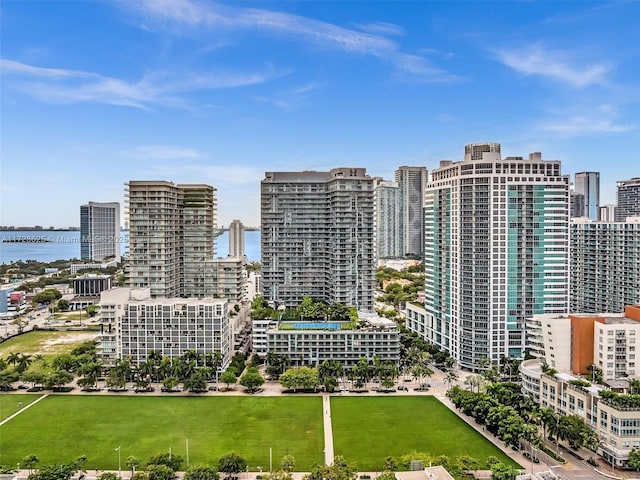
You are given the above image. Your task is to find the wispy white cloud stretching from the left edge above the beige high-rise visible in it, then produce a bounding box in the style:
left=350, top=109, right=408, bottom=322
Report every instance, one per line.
left=0, top=59, right=288, bottom=108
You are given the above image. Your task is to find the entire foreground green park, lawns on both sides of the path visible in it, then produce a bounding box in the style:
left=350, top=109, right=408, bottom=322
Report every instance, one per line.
left=0, top=394, right=512, bottom=471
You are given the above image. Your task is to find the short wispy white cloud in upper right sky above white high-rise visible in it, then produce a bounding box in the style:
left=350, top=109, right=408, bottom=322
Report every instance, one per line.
left=494, top=42, right=611, bottom=87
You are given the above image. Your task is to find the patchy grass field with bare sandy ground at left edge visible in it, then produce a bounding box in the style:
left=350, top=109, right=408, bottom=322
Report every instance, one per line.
left=0, top=330, right=98, bottom=358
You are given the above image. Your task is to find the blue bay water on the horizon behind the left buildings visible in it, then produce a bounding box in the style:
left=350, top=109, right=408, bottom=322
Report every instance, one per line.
left=0, top=230, right=260, bottom=263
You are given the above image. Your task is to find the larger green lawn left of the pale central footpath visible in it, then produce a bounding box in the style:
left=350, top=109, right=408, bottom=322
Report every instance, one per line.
left=0, top=395, right=324, bottom=471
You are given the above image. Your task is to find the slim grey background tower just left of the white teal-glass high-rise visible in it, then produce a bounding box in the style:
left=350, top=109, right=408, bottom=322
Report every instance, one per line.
left=396, top=167, right=427, bottom=258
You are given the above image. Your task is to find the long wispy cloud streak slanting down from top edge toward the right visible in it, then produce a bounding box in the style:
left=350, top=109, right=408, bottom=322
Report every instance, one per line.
left=121, top=0, right=457, bottom=81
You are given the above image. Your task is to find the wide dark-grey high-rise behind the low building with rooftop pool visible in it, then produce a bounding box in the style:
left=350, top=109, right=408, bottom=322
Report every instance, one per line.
left=261, top=168, right=375, bottom=310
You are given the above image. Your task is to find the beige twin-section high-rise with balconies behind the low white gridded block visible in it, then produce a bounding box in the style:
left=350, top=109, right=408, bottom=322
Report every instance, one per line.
left=125, top=181, right=216, bottom=298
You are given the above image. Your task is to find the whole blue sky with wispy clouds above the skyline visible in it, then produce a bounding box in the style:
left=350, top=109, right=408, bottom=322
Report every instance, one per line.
left=0, top=0, right=640, bottom=226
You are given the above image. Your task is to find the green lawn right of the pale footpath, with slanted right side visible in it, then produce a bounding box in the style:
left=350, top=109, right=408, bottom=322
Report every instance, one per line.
left=331, top=396, right=516, bottom=471
